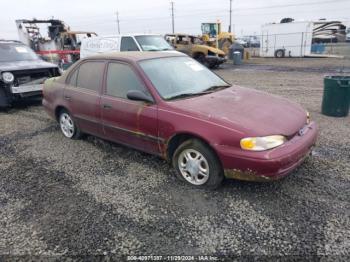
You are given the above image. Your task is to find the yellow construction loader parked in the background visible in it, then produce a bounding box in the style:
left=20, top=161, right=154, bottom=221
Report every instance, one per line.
left=202, top=22, right=235, bottom=55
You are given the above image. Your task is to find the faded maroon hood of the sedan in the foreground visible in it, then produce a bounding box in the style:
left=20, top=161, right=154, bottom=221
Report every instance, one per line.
left=169, top=86, right=307, bottom=136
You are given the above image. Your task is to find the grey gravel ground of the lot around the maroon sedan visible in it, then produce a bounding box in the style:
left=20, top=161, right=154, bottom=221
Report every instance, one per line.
left=0, top=59, right=350, bottom=260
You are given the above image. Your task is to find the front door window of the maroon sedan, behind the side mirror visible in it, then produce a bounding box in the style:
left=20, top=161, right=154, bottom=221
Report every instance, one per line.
left=106, top=63, right=146, bottom=99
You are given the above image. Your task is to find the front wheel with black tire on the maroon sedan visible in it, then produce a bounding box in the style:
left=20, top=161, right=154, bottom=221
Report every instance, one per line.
left=172, top=139, right=224, bottom=189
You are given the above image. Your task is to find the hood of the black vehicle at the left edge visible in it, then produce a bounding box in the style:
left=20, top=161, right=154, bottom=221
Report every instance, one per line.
left=0, top=59, right=57, bottom=72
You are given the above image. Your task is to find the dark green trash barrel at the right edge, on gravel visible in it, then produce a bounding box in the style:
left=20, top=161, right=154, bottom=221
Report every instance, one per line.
left=322, top=76, right=350, bottom=117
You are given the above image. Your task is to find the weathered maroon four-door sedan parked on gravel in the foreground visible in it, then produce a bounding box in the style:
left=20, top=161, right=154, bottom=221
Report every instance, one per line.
left=43, top=52, right=317, bottom=188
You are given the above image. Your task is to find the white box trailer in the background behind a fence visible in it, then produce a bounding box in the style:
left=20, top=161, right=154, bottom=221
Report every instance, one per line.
left=260, top=22, right=314, bottom=58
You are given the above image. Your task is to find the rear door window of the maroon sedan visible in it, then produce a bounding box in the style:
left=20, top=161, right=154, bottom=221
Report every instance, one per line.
left=77, top=61, right=105, bottom=92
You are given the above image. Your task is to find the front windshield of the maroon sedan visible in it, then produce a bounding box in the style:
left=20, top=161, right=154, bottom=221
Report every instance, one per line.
left=139, top=57, right=230, bottom=100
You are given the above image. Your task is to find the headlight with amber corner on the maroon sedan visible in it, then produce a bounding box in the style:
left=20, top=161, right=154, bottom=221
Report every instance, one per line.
left=241, top=135, right=287, bottom=151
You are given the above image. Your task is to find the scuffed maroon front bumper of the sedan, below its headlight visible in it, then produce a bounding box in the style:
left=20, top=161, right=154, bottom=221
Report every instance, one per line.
left=216, top=122, right=317, bottom=181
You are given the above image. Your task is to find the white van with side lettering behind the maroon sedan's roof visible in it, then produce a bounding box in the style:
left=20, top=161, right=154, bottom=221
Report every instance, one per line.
left=80, top=34, right=174, bottom=58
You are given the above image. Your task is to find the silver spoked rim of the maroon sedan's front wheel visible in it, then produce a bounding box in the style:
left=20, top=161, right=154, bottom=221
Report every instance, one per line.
left=178, top=149, right=209, bottom=186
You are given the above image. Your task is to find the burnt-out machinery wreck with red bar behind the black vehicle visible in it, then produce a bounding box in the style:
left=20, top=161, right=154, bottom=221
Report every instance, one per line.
left=16, top=19, right=97, bottom=69
